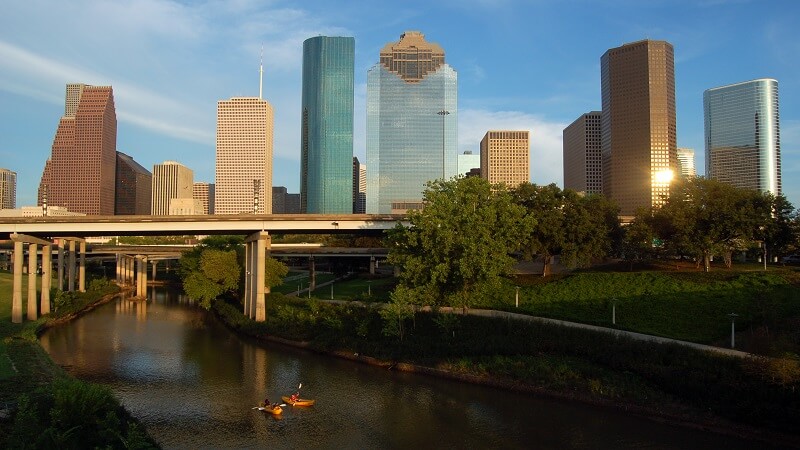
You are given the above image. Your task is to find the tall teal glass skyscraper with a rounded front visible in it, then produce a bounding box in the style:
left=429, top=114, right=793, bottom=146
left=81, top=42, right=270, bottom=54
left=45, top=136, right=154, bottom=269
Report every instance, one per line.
left=300, top=36, right=355, bottom=214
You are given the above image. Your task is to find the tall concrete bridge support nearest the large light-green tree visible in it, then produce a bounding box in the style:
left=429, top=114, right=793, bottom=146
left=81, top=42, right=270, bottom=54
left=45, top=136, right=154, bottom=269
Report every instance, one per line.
left=244, top=231, right=272, bottom=322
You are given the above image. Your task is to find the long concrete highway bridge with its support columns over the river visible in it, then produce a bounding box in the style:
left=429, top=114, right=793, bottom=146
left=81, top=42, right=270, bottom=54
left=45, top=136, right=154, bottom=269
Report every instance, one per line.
left=0, top=214, right=409, bottom=323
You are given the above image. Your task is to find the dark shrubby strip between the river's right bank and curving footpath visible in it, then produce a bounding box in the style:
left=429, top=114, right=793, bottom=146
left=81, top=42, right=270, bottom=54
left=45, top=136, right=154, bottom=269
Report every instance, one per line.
left=213, top=294, right=800, bottom=446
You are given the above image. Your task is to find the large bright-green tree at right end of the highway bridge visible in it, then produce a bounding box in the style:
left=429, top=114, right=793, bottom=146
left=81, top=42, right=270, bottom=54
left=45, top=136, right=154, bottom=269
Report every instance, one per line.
left=388, top=177, right=534, bottom=308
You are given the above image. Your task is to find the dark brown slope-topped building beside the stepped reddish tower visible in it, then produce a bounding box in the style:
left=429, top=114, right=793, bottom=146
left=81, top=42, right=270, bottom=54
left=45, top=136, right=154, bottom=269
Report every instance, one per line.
left=114, top=152, right=153, bottom=215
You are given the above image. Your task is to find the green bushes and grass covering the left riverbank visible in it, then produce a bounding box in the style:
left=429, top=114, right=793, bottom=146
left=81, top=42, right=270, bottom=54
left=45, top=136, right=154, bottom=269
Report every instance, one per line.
left=0, top=273, right=160, bottom=449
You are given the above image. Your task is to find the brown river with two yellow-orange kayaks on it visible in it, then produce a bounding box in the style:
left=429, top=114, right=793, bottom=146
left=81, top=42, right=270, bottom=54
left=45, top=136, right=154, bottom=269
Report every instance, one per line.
left=41, top=287, right=776, bottom=450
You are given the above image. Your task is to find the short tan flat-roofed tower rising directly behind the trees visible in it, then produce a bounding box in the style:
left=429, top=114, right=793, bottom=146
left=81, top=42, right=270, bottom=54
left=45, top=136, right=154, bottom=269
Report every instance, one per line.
left=481, top=131, right=531, bottom=188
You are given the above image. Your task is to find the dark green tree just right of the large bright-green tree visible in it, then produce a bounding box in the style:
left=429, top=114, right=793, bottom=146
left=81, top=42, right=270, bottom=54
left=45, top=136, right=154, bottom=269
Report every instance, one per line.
left=513, top=183, right=619, bottom=277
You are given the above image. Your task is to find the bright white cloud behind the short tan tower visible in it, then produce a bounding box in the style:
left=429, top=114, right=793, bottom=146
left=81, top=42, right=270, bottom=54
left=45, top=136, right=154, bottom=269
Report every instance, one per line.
left=458, top=109, right=568, bottom=187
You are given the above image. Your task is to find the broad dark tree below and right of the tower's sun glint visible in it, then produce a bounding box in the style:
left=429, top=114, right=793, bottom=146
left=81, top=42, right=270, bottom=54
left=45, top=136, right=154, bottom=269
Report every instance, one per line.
left=654, top=177, right=771, bottom=272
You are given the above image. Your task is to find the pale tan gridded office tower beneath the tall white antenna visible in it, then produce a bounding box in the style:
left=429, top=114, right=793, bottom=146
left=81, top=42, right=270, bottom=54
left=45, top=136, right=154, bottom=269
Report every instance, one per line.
left=214, top=97, right=273, bottom=214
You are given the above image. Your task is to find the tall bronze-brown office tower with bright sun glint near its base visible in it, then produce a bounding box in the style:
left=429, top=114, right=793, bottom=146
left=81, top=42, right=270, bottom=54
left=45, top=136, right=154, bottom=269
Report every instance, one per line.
left=600, top=40, right=678, bottom=216
